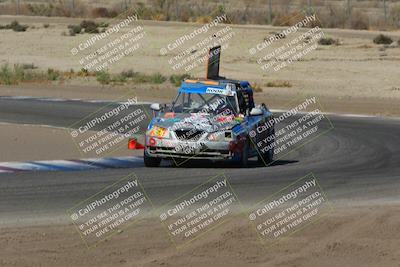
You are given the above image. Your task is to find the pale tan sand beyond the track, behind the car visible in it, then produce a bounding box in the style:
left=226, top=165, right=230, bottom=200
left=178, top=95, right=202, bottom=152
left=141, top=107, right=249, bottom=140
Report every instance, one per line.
left=0, top=16, right=400, bottom=116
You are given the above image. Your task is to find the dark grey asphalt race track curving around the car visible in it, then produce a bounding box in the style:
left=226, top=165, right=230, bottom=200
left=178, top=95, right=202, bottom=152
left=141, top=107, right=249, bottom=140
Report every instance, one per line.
left=0, top=98, right=400, bottom=224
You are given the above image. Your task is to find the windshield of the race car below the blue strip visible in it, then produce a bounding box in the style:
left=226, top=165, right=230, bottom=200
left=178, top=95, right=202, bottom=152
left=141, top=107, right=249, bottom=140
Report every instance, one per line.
left=172, top=93, right=238, bottom=114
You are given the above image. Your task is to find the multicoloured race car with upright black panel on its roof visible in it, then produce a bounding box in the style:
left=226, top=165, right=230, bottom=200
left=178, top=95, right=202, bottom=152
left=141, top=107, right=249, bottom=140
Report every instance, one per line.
left=138, top=46, right=275, bottom=167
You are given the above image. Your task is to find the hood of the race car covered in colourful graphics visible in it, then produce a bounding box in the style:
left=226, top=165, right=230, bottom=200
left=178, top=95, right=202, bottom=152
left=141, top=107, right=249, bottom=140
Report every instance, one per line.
left=154, top=113, right=243, bottom=133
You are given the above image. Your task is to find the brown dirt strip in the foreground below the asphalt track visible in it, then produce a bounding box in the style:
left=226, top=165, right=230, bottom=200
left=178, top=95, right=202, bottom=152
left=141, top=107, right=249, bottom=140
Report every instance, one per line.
left=0, top=206, right=400, bottom=267
